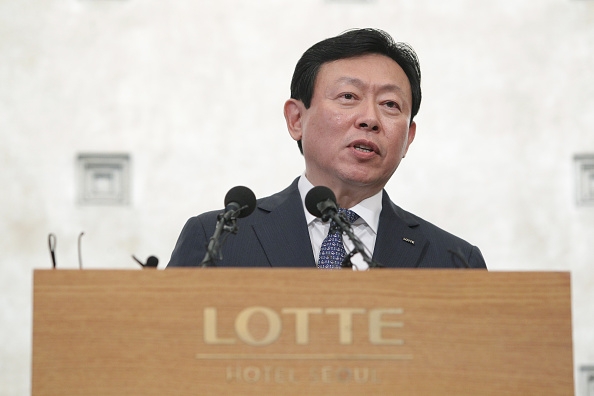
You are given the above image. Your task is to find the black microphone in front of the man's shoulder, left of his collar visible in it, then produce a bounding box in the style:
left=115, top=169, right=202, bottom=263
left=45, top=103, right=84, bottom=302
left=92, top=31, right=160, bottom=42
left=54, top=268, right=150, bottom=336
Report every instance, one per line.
left=200, top=186, right=256, bottom=267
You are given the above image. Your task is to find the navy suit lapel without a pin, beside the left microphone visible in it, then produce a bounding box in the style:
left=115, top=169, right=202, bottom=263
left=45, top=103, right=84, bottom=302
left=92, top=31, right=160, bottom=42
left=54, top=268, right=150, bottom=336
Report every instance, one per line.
left=252, top=179, right=316, bottom=268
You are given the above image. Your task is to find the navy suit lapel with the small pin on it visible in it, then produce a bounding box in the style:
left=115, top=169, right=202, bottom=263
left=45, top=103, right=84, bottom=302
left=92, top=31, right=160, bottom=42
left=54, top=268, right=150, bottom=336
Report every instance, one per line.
left=373, top=191, right=429, bottom=268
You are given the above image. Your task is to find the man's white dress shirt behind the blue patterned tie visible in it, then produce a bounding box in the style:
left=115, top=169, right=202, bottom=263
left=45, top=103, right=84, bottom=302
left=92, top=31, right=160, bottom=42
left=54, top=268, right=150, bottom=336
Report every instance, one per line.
left=298, top=174, right=382, bottom=271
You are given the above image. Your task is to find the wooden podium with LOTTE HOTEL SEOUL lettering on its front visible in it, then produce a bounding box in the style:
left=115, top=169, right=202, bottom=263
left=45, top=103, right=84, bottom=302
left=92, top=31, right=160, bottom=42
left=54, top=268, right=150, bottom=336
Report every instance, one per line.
left=32, top=268, right=574, bottom=396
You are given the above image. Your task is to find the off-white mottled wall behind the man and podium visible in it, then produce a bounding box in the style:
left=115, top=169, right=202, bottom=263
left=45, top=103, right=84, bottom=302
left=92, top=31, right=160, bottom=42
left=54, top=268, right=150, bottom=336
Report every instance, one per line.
left=0, top=0, right=594, bottom=396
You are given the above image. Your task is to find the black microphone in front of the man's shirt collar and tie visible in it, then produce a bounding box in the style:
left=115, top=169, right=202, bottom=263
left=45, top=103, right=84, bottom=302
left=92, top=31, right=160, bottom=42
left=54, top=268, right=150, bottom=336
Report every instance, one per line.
left=305, top=186, right=383, bottom=268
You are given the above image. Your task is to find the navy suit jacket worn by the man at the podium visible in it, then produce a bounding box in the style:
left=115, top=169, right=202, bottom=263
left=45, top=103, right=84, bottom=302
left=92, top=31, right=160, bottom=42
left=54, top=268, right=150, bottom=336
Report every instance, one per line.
left=168, top=179, right=486, bottom=268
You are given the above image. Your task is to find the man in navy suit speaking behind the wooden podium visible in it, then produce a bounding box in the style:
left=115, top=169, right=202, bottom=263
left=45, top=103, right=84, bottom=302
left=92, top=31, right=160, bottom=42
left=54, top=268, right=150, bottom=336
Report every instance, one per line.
left=168, top=29, right=486, bottom=270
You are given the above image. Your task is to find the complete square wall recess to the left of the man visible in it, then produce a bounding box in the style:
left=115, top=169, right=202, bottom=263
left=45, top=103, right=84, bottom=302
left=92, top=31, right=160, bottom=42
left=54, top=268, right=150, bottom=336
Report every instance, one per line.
left=77, top=153, right=130, bottom=205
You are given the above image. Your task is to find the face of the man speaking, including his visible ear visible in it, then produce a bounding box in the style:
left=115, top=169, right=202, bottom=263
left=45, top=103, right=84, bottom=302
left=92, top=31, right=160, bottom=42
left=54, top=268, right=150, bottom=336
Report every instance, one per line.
left=285, top=54, right=416, bottom=196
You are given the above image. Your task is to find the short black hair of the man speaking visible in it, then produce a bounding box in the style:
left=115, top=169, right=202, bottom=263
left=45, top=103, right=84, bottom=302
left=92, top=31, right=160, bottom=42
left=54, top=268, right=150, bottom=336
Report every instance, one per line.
left=291, top=28, right=421, bottom=153
